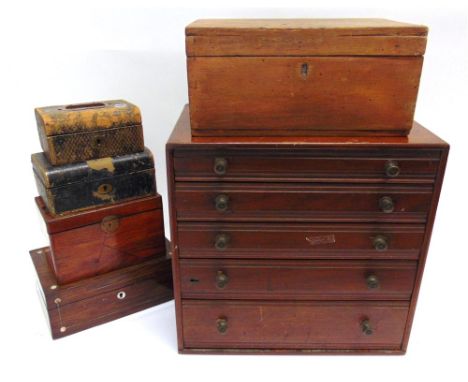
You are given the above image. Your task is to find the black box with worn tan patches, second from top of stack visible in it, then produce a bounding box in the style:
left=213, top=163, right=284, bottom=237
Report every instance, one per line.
left=31, top=149, right=156, bottom=215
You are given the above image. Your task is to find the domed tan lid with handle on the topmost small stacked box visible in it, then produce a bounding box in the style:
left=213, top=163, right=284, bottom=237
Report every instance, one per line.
left=34, top=99, right=141, bottom=136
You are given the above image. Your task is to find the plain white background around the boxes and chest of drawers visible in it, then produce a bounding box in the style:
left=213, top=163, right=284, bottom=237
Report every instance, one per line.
left=0, top=0, right=468, bottom=382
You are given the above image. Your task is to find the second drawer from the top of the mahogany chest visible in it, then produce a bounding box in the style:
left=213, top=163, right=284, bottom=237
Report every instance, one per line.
left=175, top=182, right=432, bottom=222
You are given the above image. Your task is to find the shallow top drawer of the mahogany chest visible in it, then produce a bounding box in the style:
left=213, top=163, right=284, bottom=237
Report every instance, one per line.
left=174, top=148, right=440, bottom=183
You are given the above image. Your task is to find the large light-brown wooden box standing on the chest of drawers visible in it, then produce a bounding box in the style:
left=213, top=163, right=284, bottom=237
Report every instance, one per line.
left=186, top=19, right=427, bottom=136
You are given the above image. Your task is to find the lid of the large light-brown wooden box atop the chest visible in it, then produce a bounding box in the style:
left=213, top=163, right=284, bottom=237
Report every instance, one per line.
left=185, top=19, right=428, bottom=56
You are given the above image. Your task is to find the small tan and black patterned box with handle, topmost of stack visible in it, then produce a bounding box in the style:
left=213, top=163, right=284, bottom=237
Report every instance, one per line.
left=35, top=100, right=144, bottom=166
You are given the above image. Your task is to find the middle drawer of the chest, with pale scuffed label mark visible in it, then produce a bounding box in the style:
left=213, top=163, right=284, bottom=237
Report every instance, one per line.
left=177, top=222, right=425, bottom=259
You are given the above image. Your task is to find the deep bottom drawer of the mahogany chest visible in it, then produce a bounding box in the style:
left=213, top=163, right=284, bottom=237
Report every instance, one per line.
left=182, top=300, right=408, bottom=349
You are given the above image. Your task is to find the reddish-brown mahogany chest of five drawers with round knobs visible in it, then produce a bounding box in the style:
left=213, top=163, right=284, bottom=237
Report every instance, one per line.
left=167, top=107, right=449, bottom=354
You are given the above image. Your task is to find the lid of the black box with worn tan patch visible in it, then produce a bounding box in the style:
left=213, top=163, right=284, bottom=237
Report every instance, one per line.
left=31, top=148, right=154, bottom=188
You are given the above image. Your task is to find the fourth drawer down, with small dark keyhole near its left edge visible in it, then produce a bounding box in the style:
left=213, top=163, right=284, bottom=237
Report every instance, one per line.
left=180, top=259, right=416, bottom=300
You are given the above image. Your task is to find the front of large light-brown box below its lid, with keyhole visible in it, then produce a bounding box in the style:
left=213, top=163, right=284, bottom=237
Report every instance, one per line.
left=187, top=56, right=423, bottom=136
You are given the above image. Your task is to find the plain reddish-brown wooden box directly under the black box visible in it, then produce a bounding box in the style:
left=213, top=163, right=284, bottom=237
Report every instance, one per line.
left=36, top=195, right=166, bottom=284
